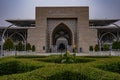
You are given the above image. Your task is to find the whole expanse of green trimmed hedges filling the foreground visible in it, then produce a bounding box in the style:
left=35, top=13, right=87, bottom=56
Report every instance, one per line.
left=0, top=55, right=120, bottom=80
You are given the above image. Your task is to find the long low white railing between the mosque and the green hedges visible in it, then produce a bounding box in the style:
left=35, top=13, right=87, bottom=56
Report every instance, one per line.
left=3, top=51, right=120, bottom=57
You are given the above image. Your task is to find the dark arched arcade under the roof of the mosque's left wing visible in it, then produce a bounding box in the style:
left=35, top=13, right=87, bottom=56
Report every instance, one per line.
left=0, top=28, right=27, bottom=45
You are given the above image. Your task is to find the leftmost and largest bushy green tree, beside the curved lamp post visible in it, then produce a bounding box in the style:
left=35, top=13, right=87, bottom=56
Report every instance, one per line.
left=3, top=38, right=14, bottom=51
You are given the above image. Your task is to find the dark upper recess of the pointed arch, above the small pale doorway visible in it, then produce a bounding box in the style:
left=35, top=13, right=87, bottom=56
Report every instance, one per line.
left=52, top=23, right=73, bottom=45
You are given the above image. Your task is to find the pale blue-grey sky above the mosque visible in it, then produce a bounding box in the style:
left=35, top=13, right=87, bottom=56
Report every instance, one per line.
left=0, top=0, right=120, bottom=26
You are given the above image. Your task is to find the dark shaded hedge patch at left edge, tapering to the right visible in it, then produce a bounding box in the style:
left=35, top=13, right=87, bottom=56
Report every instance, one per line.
left=0, top=60, right=39, bottom=76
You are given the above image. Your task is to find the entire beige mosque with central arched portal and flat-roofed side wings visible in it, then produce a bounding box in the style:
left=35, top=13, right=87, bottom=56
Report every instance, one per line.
left=0, top=7, right=120, bottom=53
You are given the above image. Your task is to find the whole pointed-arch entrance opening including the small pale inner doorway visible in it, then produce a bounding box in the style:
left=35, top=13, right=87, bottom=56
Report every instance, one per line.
left=52, top=23, right=73, bottom=52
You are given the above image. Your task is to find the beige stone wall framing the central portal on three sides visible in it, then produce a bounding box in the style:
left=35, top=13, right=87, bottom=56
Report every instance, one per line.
left=28, top=7, right=97, bottom=52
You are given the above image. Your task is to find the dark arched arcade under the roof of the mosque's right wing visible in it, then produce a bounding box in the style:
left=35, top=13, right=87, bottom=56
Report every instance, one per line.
left=97, top=28, right=120, bottom=49
